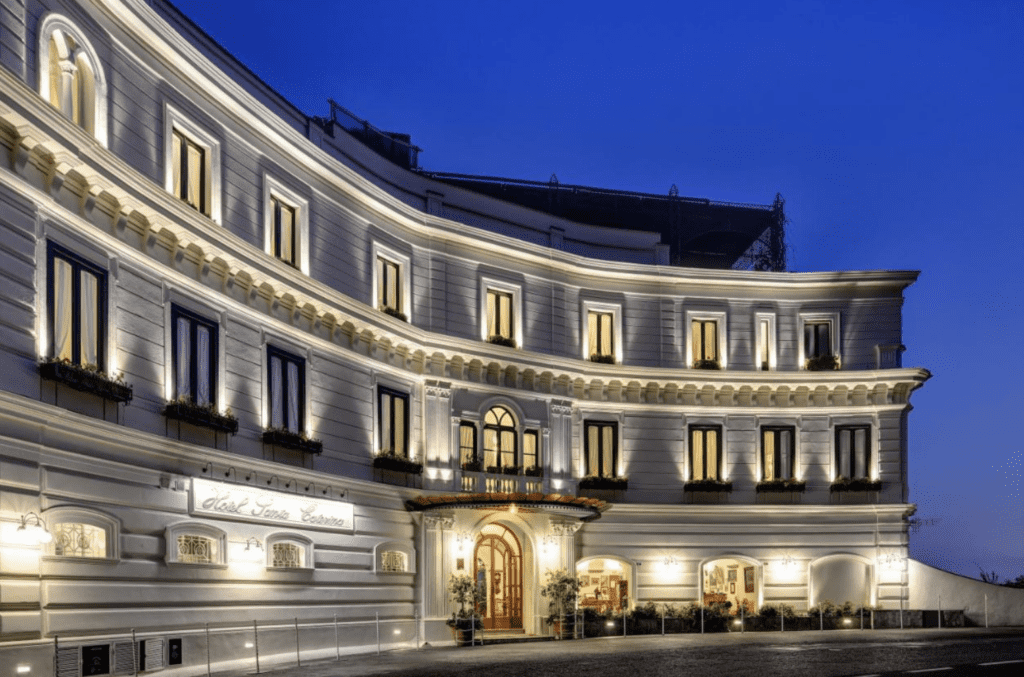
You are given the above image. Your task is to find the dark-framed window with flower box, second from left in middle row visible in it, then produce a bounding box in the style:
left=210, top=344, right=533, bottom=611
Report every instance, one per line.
left=171, top=305, right=217, bottom=406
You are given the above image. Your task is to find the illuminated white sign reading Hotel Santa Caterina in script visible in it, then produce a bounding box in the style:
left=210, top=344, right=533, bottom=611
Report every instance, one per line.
left=190, top=477, right=353, bottom=532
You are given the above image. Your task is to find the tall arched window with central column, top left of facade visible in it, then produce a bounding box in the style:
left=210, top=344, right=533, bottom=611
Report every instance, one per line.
left=39, top=14, right=106, bottom=145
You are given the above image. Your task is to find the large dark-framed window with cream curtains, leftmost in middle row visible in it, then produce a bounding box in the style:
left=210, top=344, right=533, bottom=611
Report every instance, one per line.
left=47, top=243, right=106, bottom=371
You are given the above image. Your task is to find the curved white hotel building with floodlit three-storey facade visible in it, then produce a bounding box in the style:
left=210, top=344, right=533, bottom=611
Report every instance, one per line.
left=12, top=0, right=1011, bottom=676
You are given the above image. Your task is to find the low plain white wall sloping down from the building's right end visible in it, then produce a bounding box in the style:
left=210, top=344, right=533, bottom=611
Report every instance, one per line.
left=906, top=559, right=1024, bottom=626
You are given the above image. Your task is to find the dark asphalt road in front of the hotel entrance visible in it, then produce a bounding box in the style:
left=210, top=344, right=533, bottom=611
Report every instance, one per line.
left=237, top=628, right=1024, bottom=677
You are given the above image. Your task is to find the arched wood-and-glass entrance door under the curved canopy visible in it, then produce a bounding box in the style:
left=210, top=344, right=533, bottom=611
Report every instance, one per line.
left=473, top=522, right=523, bottom=630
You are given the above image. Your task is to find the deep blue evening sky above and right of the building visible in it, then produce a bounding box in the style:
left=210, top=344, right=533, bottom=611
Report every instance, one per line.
left=169, top=0, right=1024, bottom=577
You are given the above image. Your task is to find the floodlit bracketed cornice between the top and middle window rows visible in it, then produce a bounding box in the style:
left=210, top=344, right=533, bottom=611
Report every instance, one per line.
left=0, top=69, right=931, bottom=415
